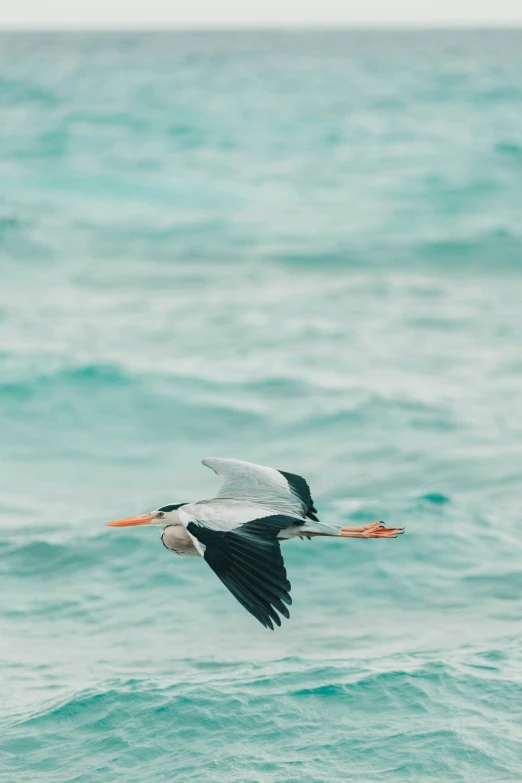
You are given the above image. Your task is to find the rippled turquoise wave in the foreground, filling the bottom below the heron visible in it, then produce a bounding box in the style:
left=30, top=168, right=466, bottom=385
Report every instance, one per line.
left=0, top=659, right=518, bottom=783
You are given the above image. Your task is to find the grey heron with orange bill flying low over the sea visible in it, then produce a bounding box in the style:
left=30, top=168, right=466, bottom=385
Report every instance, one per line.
left=107, top=457, right=404, bottom=630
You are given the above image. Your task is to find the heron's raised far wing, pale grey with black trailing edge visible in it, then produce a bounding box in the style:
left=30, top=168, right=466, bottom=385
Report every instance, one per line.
left=202, top=457, right=317, bottom=520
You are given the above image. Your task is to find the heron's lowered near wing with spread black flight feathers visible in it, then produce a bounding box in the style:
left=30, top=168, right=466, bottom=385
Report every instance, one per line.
left=187, top=514, right=302, bottom=630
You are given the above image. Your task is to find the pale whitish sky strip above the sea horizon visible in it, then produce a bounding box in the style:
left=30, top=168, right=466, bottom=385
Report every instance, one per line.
left=0, top=0, right=522, bottom=28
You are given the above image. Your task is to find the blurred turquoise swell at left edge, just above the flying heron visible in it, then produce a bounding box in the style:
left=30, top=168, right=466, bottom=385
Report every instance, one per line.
left=0, top=364, right=262, bottom=438
